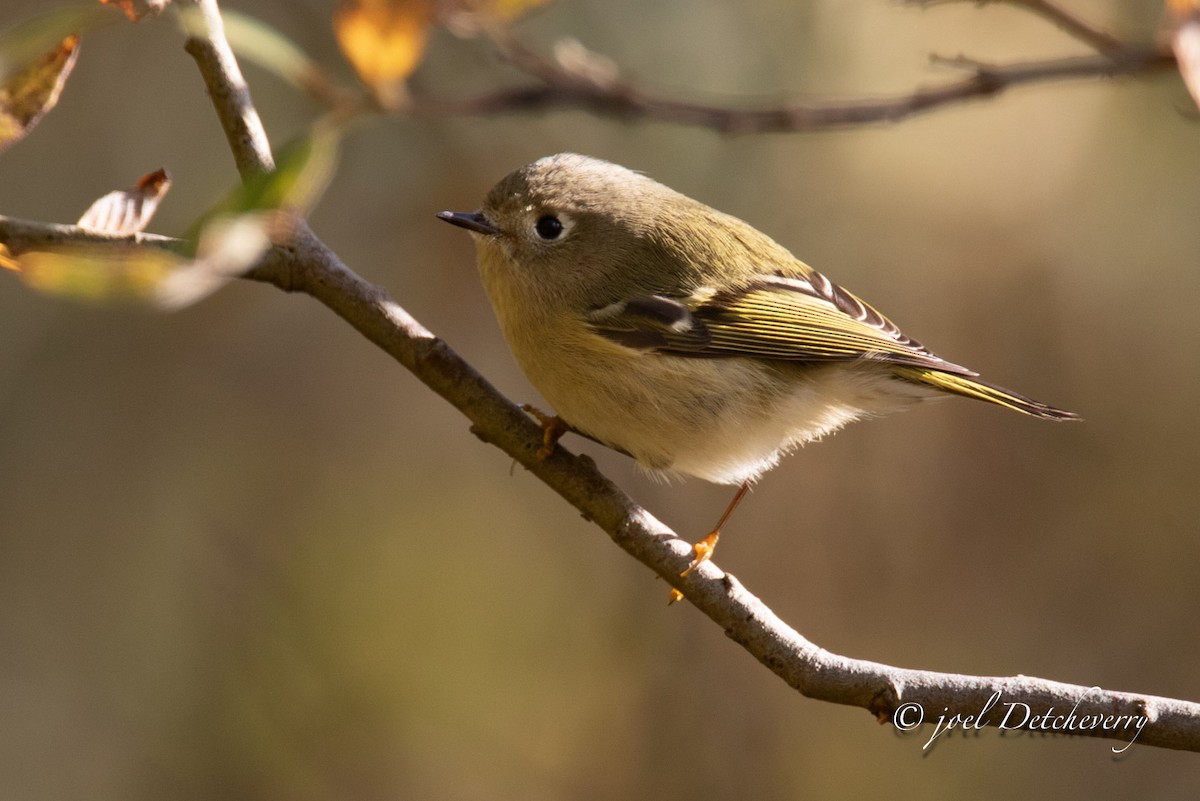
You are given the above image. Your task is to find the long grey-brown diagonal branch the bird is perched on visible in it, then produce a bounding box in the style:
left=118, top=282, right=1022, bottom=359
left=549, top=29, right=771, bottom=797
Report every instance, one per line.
left=0, top=209, right=1200, bottom=753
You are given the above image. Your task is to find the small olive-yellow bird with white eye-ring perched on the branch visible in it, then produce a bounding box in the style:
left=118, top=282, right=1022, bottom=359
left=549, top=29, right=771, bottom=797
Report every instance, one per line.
left=438, top=153, right=1079, bottom=585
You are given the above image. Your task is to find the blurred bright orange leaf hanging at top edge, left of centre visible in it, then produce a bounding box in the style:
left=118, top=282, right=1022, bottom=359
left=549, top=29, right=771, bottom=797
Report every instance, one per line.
left=334, top=0, right=434, bottom=104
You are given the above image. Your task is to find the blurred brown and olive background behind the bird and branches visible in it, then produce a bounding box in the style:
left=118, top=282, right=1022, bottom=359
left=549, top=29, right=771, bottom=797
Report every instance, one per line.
left=0, top=0, right=1200, bottom=801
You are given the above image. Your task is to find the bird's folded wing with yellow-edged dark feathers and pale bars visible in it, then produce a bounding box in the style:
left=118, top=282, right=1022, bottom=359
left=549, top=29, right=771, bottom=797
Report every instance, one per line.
left=588, top=269, right=974, bottom=375
